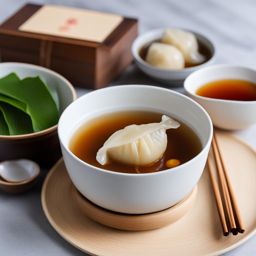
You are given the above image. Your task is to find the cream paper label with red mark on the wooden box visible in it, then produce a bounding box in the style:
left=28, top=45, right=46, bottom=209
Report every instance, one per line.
left=19, top=5, right=123, bottom=43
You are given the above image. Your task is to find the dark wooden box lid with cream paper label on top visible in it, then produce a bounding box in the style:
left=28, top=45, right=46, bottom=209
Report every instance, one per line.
left=0, top=4, right=137, bottom=48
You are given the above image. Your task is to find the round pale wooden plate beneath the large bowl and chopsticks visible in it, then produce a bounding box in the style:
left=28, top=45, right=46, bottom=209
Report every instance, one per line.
left=42, top=133, right=256, bottom=256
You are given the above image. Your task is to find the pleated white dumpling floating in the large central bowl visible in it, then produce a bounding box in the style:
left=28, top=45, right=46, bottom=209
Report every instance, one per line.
left=96, top=115, right=180, bottom=166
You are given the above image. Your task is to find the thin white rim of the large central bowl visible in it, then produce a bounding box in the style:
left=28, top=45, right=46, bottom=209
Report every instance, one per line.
left=58, top=84, right=213, bottom=177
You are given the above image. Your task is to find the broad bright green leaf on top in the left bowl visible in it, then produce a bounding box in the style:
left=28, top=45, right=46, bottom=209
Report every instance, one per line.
left=0, top=73, right=59, bottom=131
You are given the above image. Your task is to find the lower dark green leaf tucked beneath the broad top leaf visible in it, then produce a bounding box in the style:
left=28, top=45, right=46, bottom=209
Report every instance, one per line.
left=0, top=102, right=33, bottom=135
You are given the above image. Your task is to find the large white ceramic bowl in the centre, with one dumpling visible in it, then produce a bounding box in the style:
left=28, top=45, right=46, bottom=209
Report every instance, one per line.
left=58, top=85, right=212, bottom=214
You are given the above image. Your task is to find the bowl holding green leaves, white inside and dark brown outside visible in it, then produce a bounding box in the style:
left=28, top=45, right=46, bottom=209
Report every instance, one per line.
left=0, top=63, right=76, bottom=167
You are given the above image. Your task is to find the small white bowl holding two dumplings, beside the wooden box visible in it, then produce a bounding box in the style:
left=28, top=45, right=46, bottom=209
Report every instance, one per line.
left=132, top=29, right=216, bottom=85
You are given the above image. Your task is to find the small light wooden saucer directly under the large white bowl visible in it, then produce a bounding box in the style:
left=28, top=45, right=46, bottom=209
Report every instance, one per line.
left=73, top=184, right=197, bottom=231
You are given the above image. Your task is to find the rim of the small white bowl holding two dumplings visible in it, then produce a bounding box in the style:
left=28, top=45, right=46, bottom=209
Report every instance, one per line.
left=132, top=27, right=216, bottom=73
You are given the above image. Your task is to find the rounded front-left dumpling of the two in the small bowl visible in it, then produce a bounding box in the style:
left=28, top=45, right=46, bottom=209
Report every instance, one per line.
left=146, top=43, right=185, bottom=69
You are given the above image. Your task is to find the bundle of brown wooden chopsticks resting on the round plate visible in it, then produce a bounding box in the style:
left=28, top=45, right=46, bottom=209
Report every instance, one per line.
left=207, top=134, right=245, bottom=236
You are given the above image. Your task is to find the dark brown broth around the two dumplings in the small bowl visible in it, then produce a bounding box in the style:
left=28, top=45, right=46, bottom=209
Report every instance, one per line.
left=139, top=40, right=212, bottom=68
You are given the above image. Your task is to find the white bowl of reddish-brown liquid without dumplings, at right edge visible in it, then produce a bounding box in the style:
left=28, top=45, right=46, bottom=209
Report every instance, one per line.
left=184, top=65, right=256, bottom=130
